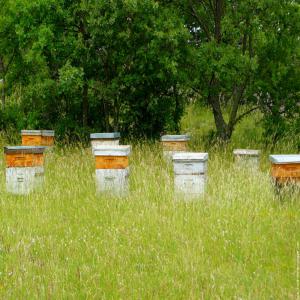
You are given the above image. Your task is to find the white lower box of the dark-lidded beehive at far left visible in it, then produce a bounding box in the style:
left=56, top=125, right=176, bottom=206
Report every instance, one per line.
left=6, top=166, right=44, bottom=195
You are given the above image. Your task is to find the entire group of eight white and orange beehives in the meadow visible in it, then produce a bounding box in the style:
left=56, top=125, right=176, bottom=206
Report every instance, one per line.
left=4, top=130, right=300, bottom=198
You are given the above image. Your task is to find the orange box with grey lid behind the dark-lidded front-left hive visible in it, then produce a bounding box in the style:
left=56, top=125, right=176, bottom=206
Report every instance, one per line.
left=21, top=130, right=54, bottom=147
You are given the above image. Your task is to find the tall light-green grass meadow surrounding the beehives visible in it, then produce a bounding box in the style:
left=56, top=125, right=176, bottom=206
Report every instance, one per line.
left=0, top=106, right=300, bottom=299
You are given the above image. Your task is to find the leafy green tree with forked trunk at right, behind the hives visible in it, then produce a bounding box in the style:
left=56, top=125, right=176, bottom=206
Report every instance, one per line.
left=180, top=0, right=299, bottom=140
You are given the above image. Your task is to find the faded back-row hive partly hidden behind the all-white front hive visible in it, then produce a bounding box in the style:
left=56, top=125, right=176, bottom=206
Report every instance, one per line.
left=161, top=134, right=190, bottom=158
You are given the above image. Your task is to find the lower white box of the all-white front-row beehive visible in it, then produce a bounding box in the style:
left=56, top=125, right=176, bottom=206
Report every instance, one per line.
left=174, top=175, right=207, bottom=198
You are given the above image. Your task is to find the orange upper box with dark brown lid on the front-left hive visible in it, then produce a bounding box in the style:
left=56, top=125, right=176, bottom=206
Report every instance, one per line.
left=4, top=146, right=45, bottom=168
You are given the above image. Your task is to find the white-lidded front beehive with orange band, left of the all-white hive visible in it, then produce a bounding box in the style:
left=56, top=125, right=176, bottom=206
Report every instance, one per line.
left=93, top=145, right=131, bottom=196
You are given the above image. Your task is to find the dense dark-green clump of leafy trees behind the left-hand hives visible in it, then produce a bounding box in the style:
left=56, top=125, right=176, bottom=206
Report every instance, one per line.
left=0, top=0, right=188, bottom=136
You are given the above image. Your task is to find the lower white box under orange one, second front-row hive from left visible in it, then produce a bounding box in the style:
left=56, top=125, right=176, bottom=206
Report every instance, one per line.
left=96, top=168, right=129, bottom=197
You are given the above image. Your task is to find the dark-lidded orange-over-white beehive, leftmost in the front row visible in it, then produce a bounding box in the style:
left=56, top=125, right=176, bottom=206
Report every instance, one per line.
left=4, top=146, right=45, bottom=194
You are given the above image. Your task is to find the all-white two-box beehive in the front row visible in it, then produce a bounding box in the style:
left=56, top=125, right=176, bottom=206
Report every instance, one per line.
left=173, top=152, right=208, bottom=199
